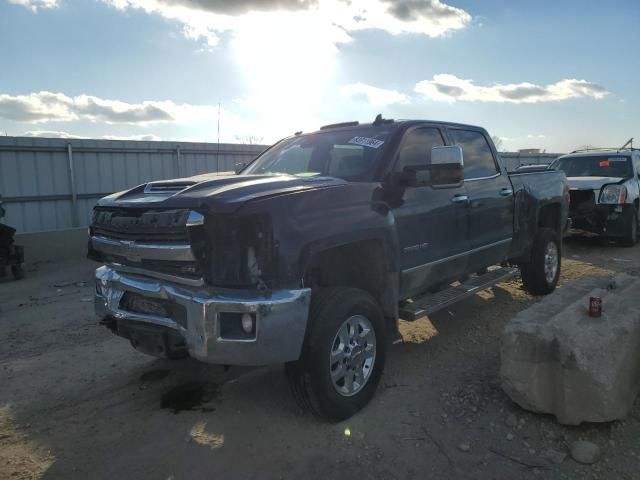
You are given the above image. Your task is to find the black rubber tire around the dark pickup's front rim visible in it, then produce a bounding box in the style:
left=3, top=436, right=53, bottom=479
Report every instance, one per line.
left=285, top=287, right=388, bottom=421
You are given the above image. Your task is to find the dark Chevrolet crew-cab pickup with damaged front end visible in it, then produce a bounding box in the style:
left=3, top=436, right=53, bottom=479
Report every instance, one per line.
left=89, top=116, right=568, bottom=420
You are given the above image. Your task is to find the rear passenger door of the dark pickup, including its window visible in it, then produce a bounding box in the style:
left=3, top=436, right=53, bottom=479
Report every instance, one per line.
left=448, top=128, right=513, bottom=272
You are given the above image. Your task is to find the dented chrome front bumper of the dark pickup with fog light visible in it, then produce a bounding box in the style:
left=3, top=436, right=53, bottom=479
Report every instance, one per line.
left=95, top=266, right=311, bottom=366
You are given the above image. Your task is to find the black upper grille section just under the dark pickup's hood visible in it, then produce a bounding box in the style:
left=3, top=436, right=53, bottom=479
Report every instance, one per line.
left=92, top=208, right=189, bottom=244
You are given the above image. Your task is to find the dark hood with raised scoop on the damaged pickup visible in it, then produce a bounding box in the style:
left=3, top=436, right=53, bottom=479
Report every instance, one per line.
left=98, top=175, right=348, bottom=213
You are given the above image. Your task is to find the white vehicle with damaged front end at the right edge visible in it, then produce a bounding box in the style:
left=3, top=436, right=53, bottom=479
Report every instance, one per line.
left=551, top=148, right=640, bottom=247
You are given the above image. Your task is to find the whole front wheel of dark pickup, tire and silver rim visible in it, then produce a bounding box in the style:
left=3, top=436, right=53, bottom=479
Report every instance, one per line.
left=285, top=287, right=388, bottom=421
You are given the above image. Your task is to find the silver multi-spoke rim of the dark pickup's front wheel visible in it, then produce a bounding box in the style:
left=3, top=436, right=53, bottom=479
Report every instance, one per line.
left=329, top=315, right=376, bottom=397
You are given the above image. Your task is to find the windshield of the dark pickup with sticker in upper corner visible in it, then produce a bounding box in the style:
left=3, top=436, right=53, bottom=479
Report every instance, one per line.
left=242, top=126, right=391, bottom=180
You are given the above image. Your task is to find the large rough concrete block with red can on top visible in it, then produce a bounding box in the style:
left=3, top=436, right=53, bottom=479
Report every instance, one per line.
left=500, top=274, right=640, bottom=425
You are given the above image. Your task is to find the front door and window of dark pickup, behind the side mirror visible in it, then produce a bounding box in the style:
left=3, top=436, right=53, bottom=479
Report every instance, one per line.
left=394, top=126, right=469, bottom=297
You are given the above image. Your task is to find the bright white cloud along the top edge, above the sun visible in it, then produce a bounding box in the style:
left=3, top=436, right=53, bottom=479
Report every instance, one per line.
left=102, top=0, right=471, bottom=47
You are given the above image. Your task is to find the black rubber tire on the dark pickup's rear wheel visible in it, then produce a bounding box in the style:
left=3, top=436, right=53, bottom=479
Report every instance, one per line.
left=520, top=228, right=562, bottom=295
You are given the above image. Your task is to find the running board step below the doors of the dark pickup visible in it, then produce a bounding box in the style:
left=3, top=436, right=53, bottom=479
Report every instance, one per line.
left=400, top=267, right=518, bottom=322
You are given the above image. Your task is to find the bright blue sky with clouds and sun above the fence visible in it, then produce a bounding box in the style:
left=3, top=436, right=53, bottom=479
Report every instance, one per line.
left=0, top=0, right=640, bottom=152
